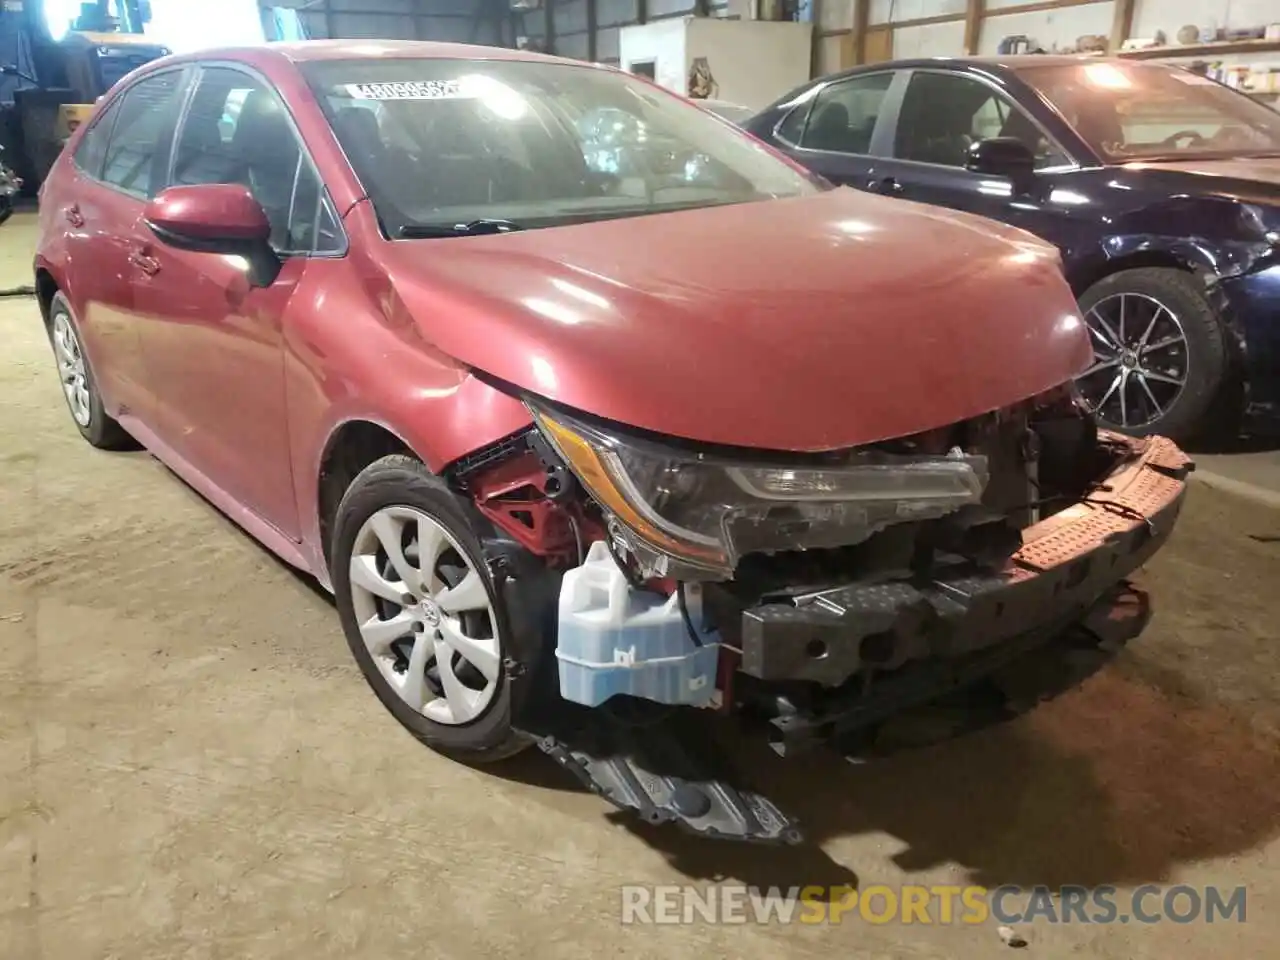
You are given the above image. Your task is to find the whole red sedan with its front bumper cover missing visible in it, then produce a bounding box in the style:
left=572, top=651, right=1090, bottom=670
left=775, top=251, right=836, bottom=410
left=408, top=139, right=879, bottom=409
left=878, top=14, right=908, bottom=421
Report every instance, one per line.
left=36, top=42, right=1188, bottom=838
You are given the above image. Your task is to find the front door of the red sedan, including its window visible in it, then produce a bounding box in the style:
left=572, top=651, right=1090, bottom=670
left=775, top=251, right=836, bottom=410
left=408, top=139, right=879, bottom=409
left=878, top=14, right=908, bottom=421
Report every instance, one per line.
left=134, top=67, right=343, bottom=539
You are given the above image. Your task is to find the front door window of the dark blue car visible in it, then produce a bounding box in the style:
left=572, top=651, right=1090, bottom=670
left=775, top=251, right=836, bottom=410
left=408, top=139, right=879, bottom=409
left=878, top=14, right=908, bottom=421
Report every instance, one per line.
left=893, top=70, right=1070, bottom=169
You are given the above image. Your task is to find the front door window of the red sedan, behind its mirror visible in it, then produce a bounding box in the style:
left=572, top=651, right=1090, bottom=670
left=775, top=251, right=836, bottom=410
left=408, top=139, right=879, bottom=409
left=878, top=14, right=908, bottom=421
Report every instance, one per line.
left=172, top=67, right=342, bottom=253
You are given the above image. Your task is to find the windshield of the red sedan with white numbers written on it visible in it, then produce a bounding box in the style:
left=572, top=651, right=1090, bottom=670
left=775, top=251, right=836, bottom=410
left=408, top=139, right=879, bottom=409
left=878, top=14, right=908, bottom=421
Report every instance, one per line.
left=305, top=59, right=822, bottom=237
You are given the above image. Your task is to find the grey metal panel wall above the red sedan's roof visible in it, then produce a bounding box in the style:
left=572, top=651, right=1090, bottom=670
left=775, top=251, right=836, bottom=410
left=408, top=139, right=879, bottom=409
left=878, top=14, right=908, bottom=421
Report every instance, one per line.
left=261, top=0, right=730, bottom=64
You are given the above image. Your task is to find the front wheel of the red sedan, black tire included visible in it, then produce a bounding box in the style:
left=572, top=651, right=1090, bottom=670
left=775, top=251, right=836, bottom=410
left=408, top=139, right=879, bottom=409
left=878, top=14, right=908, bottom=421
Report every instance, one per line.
left=330, top=454, right=529, bottom=763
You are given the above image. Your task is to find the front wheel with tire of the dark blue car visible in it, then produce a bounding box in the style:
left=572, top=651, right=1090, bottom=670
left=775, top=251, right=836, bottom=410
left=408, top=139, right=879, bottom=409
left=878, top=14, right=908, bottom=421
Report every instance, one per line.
left=1076, top=268, right=1231, bottom=443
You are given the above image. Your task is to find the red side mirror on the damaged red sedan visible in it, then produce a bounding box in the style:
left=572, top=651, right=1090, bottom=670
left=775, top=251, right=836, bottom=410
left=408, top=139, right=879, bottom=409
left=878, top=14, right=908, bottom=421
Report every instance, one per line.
left=142, top=183, right=280, bottom=287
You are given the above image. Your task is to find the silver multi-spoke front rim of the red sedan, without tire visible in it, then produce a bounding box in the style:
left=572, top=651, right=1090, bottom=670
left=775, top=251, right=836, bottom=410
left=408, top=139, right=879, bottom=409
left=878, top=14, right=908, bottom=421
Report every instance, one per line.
left=351, top=507, right=502, bottom=724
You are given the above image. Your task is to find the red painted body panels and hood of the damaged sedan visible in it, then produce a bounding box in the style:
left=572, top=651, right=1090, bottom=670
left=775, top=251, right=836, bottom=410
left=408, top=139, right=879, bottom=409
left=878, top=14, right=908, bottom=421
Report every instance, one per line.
left=36, top=41, right=1091, bottom=585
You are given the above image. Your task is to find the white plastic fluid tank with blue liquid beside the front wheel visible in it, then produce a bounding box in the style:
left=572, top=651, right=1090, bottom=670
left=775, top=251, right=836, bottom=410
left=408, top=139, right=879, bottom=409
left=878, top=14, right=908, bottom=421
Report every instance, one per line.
left=556, top=541, right=719, bottom=707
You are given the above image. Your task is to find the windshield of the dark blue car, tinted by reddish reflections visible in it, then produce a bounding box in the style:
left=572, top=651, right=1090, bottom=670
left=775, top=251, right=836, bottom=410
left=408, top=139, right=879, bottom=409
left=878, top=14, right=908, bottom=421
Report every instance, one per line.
left=1019, top=61, right=1280, bottom=163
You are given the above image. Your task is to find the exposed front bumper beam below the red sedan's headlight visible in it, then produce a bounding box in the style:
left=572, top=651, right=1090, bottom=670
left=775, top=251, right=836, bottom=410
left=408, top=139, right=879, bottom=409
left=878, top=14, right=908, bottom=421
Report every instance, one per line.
left=740, top=436, right=1193, bottom=686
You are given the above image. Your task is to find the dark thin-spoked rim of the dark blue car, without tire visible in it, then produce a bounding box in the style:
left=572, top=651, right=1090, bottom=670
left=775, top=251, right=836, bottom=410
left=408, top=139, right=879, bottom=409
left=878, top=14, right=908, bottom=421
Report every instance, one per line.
left=1076, top=293, right=1190, bottom=430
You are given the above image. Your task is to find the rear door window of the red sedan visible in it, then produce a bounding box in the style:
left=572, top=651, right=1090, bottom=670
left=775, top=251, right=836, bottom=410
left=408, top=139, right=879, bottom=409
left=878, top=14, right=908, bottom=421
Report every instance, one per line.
left=95, top=70, right=184, bottom=197
